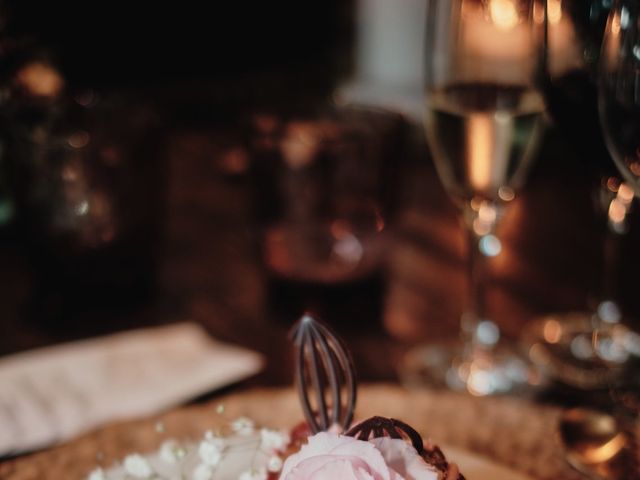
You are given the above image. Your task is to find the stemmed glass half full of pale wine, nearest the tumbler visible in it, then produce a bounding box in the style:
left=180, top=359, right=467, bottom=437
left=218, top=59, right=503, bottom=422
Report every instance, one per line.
left=407, top=0, right=544, bottom=395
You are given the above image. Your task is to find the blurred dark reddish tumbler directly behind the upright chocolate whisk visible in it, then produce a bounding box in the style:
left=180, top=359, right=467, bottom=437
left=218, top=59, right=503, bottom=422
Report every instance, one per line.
left=251, top=107, right=404, bottom=322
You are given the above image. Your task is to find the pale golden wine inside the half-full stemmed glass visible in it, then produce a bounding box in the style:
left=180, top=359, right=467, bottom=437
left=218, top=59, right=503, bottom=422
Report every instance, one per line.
left=426, top=83, right=544, bottom=203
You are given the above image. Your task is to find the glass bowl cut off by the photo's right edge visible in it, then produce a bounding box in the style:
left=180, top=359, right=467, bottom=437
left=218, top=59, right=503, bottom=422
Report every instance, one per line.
left=598, top=0, right=640, bottom=195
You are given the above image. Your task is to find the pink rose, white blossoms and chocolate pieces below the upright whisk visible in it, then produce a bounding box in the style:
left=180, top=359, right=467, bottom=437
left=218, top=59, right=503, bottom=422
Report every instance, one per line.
left=86, top=417, right=464, bottom=480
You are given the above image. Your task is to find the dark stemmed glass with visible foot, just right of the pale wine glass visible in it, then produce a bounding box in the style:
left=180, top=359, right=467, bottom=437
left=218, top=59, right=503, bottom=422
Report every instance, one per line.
left=524, top=0, right=637, bottom=389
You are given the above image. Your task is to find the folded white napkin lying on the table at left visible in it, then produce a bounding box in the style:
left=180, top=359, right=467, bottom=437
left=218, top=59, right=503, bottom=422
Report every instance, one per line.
left=0, top=323, right=263, bottom=456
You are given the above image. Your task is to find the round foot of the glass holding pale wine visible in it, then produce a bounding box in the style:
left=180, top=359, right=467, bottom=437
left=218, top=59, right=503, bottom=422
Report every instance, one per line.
left=400, top=342, right=540, bottom=396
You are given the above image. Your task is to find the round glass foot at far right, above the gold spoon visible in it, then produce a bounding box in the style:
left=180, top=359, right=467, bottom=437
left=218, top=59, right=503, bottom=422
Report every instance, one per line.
left=523, top=311, right=640, bottom=389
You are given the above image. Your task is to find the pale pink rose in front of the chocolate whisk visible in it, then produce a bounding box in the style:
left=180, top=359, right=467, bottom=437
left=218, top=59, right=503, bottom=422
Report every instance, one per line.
left=280, top=432, right=438, bottom=480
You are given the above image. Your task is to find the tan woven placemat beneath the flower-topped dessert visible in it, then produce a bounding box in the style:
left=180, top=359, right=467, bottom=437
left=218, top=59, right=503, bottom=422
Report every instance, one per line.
left=0, top=384, right=582, bottom=480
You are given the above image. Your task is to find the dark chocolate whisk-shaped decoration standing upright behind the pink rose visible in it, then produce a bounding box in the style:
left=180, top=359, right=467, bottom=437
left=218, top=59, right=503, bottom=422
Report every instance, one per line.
left=292, top=313, right=356, bottom=433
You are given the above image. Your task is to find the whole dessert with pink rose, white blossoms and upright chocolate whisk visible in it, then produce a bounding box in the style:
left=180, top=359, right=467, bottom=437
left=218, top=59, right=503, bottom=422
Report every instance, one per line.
left=87, top=314, right=464, bottom=480
